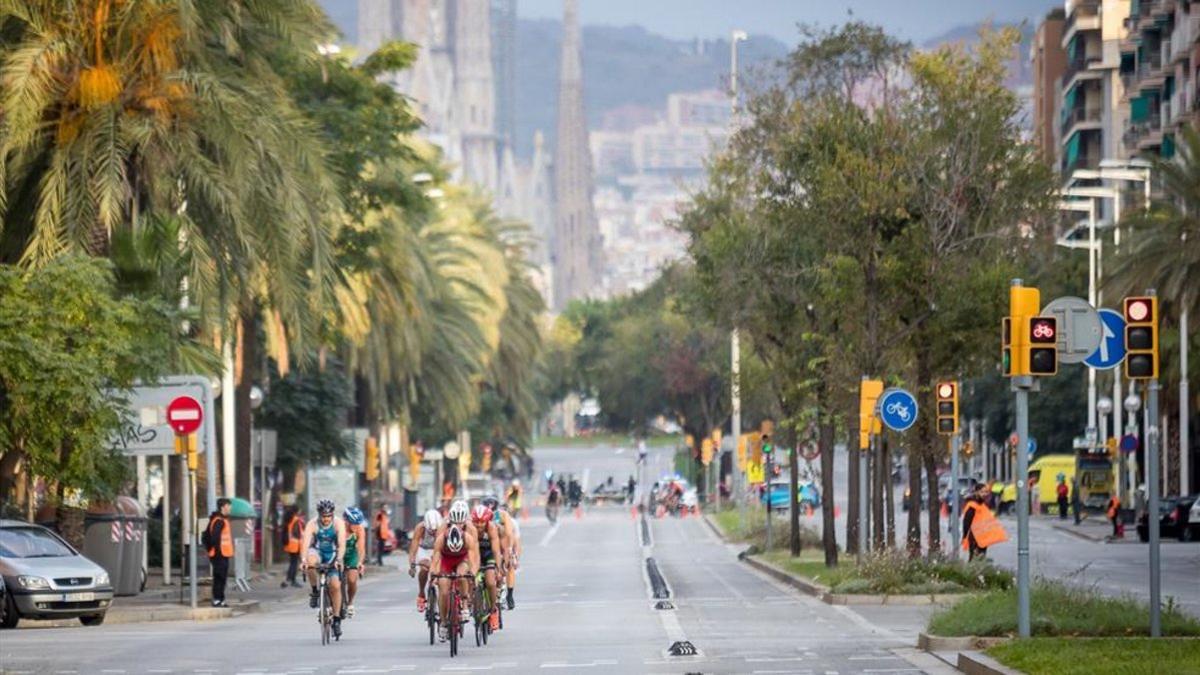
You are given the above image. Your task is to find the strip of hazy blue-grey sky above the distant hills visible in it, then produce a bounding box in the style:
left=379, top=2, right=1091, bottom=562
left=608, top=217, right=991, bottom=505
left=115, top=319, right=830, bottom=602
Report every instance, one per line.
left=517, top=0, right=1063, bottom=46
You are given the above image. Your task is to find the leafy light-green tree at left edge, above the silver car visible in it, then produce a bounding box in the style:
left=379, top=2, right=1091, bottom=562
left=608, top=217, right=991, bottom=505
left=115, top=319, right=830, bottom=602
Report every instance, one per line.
left=0, top=256, right=173, bottom=543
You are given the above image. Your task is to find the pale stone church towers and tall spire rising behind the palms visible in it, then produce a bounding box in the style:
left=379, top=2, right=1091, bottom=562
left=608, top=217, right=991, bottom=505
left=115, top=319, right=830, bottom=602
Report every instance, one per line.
left=359, top=0, right=602, bottom=310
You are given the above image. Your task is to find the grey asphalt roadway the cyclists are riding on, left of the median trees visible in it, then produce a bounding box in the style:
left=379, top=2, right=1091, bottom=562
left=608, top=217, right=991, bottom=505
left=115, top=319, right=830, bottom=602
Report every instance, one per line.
left=0, top=448, right=936, bottom=675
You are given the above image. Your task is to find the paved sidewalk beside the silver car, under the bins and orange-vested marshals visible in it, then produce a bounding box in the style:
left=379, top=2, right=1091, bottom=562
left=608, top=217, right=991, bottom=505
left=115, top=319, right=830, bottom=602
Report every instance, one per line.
left=20, top=556, right=400, bottom=628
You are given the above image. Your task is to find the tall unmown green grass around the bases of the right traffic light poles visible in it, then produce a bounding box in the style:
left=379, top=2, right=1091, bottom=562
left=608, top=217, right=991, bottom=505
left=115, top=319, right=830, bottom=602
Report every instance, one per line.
left=929, top=580, right=1200, bottom=638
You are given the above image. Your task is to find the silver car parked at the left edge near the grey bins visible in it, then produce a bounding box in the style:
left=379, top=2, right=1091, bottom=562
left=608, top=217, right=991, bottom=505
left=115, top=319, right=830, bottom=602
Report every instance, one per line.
left=0, top=520, right=113, bottom=628
